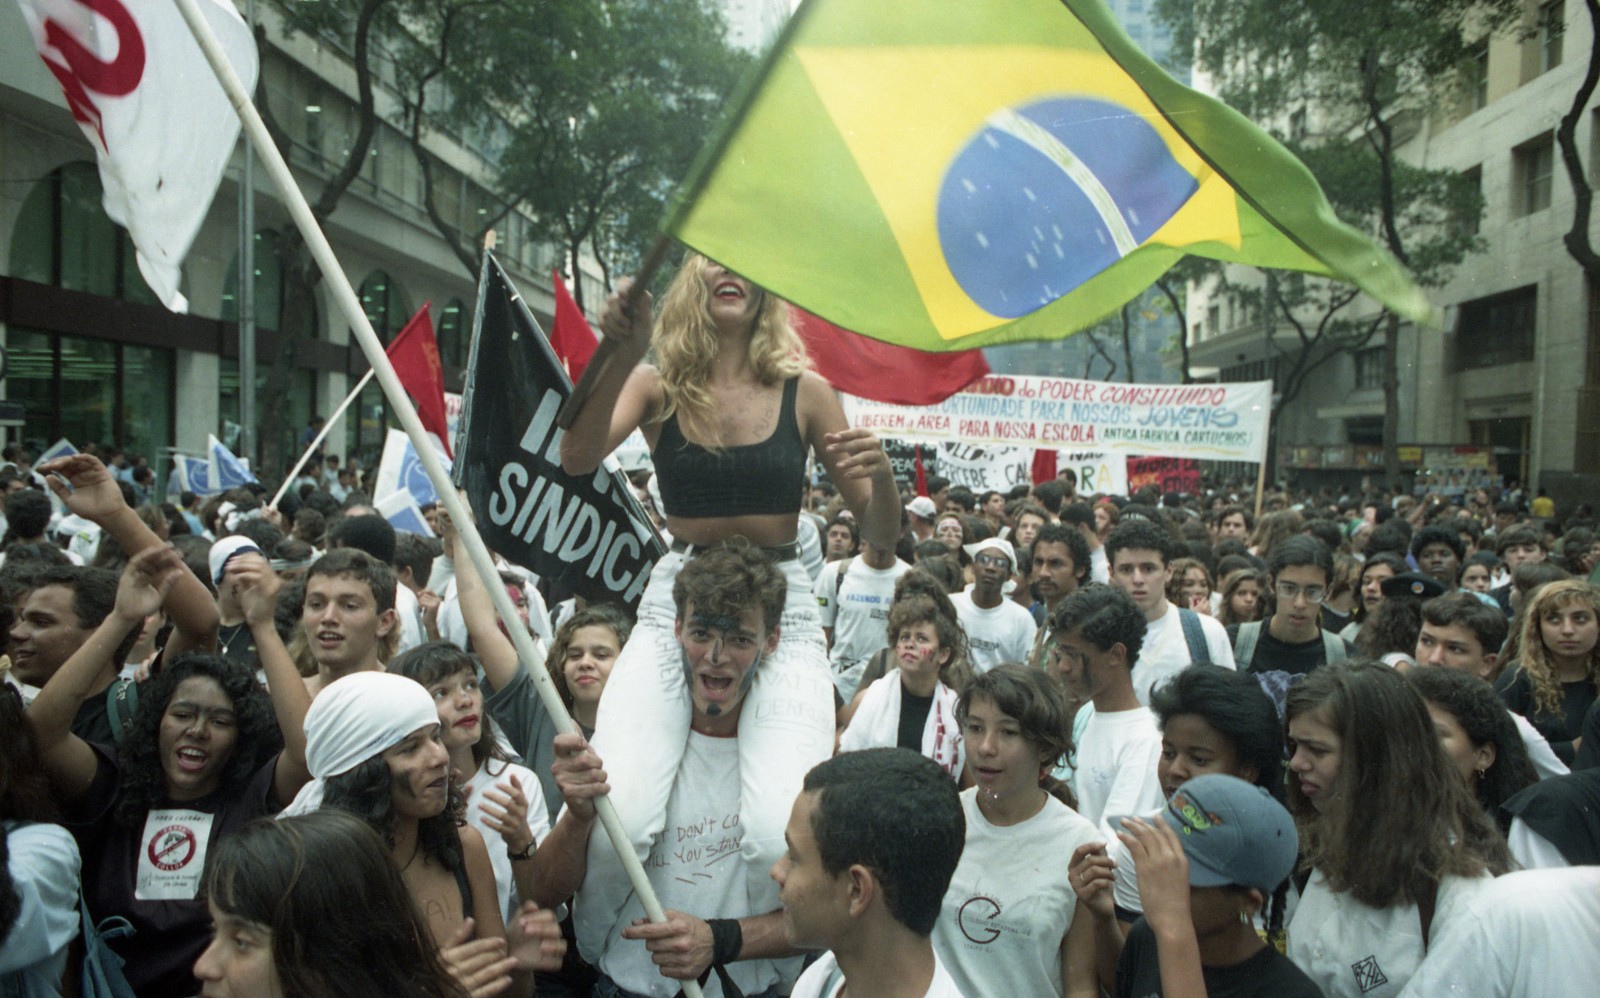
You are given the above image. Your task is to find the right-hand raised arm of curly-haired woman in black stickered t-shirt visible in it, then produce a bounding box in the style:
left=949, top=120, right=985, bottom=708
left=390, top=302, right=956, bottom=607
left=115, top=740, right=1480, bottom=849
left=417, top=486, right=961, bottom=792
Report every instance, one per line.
left=222, top=553, right=310, bottom=804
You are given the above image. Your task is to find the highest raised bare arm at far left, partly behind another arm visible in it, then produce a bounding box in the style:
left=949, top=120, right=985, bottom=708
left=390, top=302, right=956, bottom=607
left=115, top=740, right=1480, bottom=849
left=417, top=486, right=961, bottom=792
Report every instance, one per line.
left=38, top=454, right=219, bottom=654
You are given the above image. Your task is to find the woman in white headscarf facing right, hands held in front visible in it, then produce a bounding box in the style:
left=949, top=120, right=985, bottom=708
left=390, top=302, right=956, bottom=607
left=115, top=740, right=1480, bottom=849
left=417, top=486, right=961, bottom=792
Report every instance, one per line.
left=302, top=672, right=565, bottom=995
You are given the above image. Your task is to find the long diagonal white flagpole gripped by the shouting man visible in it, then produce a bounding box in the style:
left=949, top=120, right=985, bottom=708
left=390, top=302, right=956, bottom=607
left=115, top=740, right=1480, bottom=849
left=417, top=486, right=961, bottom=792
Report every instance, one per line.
left=176, top=0, right=704, bottom=998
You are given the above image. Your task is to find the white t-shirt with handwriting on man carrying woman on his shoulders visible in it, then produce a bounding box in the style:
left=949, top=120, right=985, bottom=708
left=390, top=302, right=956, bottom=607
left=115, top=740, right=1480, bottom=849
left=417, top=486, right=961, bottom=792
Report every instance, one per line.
left=600, top=731, right=778, bottom=998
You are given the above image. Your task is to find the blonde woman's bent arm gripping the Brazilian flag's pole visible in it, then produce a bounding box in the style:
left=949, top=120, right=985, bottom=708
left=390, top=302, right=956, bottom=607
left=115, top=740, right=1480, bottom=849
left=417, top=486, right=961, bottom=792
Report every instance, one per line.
left=562, top=278, right=659, bottom=475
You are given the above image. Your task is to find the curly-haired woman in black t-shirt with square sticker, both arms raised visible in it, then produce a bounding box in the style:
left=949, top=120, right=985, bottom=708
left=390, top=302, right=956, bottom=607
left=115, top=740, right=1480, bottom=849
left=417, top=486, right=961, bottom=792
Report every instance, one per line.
left=29, top=547, right=310, bottom=998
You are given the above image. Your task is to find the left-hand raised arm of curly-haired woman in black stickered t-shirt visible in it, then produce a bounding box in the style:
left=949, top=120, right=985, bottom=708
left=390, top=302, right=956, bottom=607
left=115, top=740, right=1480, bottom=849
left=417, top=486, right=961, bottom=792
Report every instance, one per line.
left=27, top=547, right=189, bottom=801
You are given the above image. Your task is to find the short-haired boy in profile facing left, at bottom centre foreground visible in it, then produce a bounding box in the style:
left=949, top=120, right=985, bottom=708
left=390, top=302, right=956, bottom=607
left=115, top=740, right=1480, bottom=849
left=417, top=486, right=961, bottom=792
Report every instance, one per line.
left=771, top=749, right=966, bottom=998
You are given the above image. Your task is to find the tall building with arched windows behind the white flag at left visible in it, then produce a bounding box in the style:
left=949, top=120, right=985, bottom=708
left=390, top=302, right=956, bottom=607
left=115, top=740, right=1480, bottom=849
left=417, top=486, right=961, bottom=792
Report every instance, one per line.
left=0, top=2, right=588, bottom=477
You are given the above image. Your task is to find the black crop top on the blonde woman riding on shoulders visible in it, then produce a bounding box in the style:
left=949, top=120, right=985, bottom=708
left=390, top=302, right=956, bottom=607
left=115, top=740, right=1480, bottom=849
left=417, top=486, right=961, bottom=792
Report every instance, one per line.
left=651, top=377, right=806, bottom=518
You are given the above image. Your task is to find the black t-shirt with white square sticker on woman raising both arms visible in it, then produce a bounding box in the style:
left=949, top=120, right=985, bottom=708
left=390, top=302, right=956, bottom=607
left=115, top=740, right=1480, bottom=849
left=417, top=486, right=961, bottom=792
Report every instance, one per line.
left=67, top=745, right=278, bottom=998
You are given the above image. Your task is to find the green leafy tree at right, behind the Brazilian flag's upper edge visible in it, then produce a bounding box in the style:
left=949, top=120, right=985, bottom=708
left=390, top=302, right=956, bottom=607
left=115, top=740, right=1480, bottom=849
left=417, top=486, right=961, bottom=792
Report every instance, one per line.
left=1160, top=0, right=1523, bottom=486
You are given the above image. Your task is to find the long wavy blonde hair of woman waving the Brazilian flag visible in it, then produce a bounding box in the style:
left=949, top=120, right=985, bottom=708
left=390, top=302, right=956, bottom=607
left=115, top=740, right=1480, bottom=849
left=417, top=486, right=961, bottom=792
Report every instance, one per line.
left=651, top=253, right=810, bottom=448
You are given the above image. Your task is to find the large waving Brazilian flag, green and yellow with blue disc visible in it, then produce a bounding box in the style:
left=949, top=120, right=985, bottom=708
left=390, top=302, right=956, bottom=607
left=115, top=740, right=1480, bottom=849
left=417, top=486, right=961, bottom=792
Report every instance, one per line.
left=662, top=0, right=1435, bottom=350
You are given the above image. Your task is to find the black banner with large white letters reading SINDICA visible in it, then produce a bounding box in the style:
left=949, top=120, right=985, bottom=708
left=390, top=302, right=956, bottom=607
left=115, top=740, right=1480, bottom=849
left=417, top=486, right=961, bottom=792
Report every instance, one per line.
left=454, top=253, right=666, bottom=608
